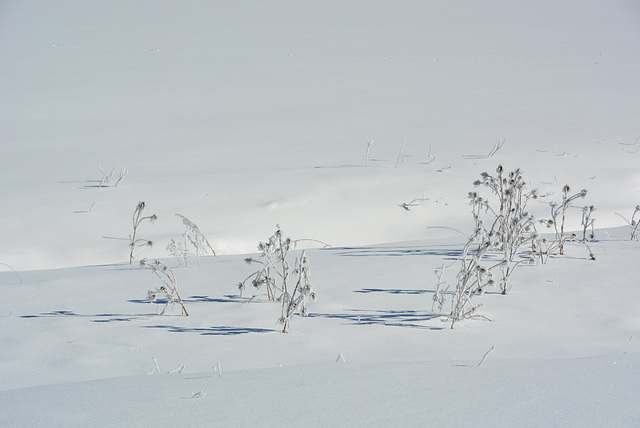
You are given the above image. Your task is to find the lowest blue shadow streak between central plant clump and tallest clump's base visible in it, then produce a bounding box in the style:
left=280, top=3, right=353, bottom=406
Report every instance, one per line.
left=308, top=309, right=443, bottom=330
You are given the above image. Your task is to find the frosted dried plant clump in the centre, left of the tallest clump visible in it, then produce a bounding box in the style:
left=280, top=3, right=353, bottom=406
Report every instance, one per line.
left=238, top=225, right=317, bottom=333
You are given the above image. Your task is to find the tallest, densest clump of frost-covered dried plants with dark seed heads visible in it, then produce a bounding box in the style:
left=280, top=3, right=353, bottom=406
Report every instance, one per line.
left=433, top=165, right=540, bottom=328
